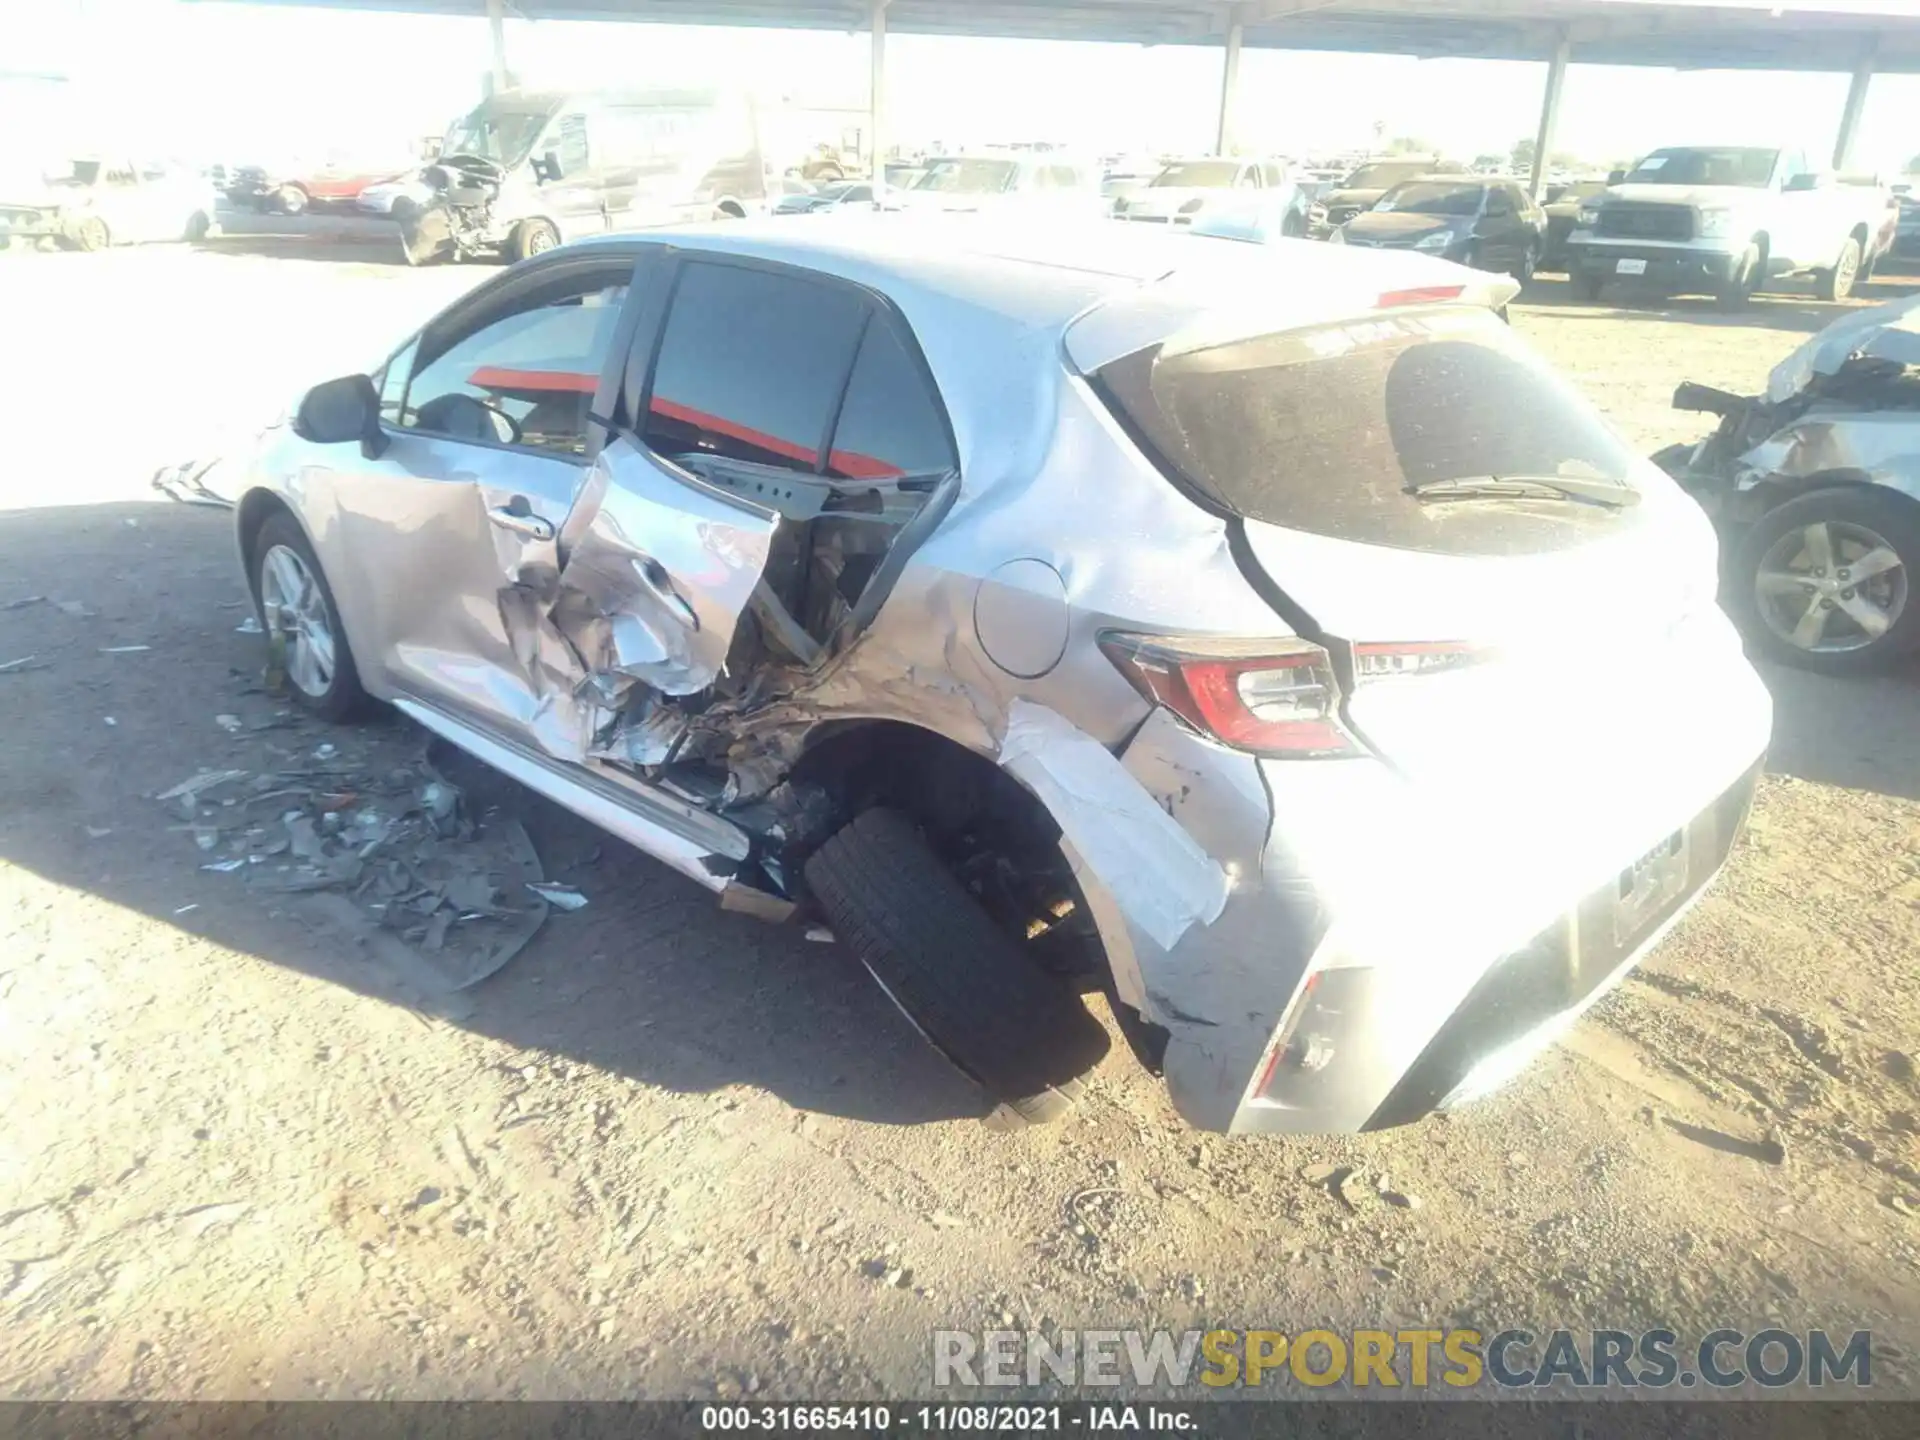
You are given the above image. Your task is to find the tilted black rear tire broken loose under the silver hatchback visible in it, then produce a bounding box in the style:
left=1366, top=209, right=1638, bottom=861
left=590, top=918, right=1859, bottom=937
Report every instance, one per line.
left=806, top=808, right=1108, bottom=1123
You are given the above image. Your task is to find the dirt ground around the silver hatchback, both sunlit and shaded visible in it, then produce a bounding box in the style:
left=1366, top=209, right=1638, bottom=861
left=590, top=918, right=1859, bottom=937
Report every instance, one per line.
left=0, top=242, right=1920, bottom=1398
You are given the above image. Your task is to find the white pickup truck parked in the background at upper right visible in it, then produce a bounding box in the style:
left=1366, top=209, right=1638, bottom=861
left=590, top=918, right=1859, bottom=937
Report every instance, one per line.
left=1567, top=146, right=1891, bottom=309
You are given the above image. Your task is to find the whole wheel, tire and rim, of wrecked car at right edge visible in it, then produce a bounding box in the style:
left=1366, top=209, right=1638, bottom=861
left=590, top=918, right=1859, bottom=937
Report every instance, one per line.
left=1732, top=486, right=1920, bottom=674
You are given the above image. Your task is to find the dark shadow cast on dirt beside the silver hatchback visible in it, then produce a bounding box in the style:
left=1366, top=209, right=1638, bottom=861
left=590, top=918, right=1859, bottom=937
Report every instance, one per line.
left=0, top=503, right=987, bottom=1125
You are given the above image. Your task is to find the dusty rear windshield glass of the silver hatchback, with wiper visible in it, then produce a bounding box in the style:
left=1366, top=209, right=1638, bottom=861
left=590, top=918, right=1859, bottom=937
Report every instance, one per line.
left=1094, top=307, right=1640, bottom=555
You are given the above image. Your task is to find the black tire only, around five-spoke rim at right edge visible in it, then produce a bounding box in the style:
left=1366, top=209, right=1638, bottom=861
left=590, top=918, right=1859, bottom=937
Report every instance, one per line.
left=1728, top=486, right=1920, bottom=676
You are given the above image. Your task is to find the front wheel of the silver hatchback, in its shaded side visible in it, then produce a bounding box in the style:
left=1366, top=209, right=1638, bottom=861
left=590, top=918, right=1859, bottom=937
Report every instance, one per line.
left=253, top=515, right=367, bottom=720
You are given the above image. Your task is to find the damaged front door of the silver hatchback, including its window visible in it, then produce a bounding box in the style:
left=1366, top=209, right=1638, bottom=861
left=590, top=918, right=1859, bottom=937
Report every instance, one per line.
left=332, top=253, right=634, bottom=753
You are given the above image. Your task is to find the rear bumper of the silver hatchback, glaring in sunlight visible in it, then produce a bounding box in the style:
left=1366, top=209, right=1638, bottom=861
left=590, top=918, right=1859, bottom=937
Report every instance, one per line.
left=1083, top=612, right=1770, bottom=1133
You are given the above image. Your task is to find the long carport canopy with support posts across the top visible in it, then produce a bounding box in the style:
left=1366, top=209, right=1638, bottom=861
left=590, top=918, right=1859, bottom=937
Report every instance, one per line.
left=224, top=0, right=1920, bottom=192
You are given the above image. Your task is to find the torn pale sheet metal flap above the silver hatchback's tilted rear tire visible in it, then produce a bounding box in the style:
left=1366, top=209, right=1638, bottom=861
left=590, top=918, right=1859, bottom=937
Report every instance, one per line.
left=1000, top=701, right=1229, bottom=950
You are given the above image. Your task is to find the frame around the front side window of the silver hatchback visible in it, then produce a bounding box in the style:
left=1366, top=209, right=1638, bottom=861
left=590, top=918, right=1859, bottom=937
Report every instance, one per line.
left=374, top=246, right=647, bottom=467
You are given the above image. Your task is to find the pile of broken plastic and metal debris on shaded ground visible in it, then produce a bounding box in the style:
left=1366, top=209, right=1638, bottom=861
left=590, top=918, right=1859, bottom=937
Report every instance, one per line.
left=156, top=743, right=552, bottom=991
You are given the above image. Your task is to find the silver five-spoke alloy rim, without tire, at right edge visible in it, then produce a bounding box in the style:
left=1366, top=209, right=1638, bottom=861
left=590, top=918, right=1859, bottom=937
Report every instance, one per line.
left=1753, top=520, right=1907, bottom=655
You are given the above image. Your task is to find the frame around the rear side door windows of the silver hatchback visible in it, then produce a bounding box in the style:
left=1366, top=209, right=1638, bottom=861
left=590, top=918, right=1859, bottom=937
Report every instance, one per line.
left=616, top=246, right=962, bottom=515
